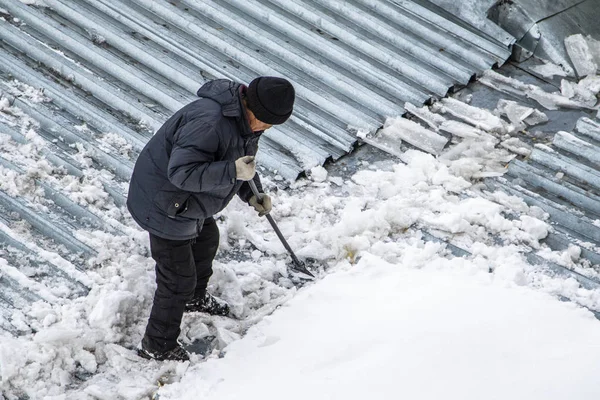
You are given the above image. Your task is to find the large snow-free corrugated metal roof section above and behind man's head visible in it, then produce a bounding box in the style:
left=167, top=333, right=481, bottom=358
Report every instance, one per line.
left=0, top=0, right=509, bottom=179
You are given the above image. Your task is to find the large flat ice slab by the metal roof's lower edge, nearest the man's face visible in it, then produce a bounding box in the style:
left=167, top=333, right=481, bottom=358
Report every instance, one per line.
left=379, top=117, right=448, bottom=155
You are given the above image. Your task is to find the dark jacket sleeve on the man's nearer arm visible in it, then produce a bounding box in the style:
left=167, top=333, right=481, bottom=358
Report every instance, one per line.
left=167, top=120, right=236, bottom=192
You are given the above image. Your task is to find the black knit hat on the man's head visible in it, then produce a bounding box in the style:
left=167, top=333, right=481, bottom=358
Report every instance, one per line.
left=246, top=76, right=296, bottom=125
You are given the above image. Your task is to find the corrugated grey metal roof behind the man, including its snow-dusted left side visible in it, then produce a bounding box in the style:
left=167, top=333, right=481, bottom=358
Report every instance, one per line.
left=0, top=0, right=510, bottom=330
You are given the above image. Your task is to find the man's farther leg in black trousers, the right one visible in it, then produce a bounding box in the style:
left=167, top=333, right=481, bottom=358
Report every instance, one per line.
left=192, top=217, right=219, bottom=299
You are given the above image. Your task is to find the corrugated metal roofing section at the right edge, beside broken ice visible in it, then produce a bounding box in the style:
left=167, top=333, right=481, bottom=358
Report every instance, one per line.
left=499, top=118, right=600, bottom=265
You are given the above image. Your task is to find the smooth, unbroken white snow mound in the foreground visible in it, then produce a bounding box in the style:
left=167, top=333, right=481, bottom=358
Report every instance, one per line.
left=159, top=255, right=600, bottom=400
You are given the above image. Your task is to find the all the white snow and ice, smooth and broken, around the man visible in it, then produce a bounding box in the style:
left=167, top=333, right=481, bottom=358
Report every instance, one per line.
left=0, top=20, right=600, bottom=400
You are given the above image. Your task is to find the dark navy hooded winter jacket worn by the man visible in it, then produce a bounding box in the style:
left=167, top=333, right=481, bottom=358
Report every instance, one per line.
left=127, top=79, right=262, bottom=240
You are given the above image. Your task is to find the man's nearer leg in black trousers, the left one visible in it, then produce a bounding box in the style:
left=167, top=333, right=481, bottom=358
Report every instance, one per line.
left=144, top=234, right=196, bottom=352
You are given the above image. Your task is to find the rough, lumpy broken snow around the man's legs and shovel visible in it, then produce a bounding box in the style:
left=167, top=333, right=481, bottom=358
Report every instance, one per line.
left=0, top=134, right=598, bottom=400
